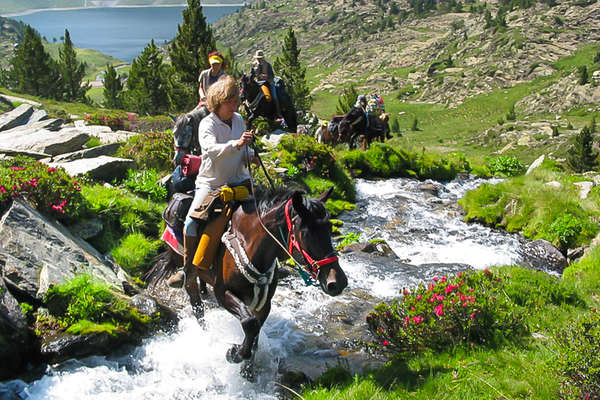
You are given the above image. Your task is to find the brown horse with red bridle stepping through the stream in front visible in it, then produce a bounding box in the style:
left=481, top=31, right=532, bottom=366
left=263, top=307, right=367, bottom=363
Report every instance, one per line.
left=147, top=189, right=348, bottom=363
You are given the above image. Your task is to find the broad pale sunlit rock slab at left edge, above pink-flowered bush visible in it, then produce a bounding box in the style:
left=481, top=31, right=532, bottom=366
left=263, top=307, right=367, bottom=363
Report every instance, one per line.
left=2, top=128, right=90, bottom=156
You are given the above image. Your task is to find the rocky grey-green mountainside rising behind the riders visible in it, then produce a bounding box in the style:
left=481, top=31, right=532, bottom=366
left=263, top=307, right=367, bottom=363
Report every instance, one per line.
left=214, top=0, right=600, bottom=113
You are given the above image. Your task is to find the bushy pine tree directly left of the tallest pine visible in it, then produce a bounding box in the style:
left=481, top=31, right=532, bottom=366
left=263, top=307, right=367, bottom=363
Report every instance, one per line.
left=125, top=39, right=169, bottom=115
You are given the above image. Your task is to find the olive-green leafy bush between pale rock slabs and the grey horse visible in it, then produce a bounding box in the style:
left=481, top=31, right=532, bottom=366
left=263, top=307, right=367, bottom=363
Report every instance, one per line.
left=117, top=131, right=173, bottom=172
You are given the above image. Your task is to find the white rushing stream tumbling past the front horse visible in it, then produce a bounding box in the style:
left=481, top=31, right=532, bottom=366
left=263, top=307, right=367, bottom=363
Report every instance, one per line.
left=0, top=179, right=524, bottom=400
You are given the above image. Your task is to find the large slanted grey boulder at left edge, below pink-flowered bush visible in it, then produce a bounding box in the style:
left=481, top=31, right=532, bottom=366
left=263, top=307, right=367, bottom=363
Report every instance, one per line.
left=0, top=200, right=126, bottom=300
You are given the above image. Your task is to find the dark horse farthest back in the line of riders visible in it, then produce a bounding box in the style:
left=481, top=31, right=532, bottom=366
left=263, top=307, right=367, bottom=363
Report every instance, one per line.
left=338, top=107, right=391, bottom=150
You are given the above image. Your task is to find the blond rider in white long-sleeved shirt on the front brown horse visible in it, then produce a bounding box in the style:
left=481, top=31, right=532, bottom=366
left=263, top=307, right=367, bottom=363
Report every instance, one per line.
left=168, top=75, right=253, bottom=287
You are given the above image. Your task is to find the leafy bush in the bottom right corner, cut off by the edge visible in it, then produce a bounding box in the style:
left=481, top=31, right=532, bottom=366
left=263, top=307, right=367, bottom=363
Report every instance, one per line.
left=557, top=309, right=600, bottom=399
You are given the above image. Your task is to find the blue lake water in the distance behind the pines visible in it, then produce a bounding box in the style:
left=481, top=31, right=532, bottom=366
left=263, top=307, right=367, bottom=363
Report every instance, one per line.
left=12, top=6, right=240, bottom=62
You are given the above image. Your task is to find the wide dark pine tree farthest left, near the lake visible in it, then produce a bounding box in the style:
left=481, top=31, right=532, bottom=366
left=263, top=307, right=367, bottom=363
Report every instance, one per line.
left=8, top=25, right=60, bottom=98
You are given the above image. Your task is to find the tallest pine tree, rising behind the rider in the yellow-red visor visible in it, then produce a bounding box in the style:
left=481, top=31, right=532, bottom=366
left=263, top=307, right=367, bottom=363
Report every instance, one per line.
left=169, top=0, right=216, bottom=109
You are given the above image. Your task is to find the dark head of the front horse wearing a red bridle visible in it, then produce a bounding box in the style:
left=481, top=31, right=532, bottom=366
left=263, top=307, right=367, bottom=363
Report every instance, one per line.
left=286, top=188, right=348, bottom=296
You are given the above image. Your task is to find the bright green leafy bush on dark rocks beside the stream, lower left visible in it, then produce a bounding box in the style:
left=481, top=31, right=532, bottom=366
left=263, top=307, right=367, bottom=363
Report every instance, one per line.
left=44, top=274, right=150, bottom=333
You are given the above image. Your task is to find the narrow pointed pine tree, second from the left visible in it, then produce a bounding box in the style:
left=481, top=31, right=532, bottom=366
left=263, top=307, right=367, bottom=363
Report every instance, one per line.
left=58, top=29, right=90, bottom=101
